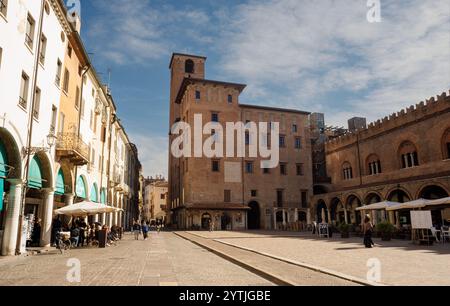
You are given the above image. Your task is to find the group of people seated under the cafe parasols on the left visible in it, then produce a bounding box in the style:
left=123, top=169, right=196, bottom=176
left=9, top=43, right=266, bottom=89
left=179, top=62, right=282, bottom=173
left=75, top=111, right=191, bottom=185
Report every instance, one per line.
left=51, top=216, right=121, bottom=247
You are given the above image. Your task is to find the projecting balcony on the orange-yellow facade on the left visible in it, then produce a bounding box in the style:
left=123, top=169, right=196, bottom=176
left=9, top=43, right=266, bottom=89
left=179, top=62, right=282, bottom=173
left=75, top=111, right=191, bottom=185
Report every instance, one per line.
left=56, top=133, right=89, bottom=166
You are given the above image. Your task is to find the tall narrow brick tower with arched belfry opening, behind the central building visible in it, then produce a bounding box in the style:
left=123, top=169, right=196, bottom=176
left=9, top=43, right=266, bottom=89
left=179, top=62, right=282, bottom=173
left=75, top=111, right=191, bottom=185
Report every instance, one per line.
left=168, top=53, right=206, bottom=222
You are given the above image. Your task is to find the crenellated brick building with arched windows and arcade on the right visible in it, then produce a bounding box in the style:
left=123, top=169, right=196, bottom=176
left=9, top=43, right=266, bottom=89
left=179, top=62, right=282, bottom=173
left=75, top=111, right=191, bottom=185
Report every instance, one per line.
left=311, top=93, right=450, bottom=224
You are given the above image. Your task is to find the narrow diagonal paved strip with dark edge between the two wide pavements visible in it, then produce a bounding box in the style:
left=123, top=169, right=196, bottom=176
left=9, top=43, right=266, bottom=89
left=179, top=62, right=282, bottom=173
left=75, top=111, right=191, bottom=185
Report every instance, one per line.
left=176, top=232, right=358, bottom=286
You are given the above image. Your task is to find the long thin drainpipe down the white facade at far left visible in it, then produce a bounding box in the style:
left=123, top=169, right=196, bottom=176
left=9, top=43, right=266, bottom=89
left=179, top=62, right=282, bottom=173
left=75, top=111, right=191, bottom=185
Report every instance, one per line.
left=16, top=0, right=45, bottom=255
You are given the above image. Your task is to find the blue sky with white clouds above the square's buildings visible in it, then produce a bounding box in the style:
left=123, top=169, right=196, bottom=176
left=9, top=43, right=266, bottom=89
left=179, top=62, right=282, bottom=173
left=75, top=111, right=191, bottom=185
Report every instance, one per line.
left=81, top=0, right=450, bottom=175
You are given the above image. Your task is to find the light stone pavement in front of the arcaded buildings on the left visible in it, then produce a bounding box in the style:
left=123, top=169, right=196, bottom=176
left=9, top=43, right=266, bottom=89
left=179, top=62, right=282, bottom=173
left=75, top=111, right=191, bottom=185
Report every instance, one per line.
left=0, top=232, right=273, bottom=286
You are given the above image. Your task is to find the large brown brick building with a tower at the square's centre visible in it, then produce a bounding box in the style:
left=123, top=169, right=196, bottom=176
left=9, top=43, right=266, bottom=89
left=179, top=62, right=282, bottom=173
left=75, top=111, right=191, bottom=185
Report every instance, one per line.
left=168, top=54, right=312, bottom=230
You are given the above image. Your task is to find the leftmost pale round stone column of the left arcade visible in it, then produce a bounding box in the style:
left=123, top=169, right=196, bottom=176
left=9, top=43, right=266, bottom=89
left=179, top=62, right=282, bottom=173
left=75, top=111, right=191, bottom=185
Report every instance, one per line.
left=2, top=180, right=23, bottom=256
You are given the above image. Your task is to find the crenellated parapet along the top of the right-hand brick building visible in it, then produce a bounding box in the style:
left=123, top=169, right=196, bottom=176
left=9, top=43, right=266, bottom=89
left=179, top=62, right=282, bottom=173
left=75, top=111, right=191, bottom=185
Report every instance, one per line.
left=326, top=91, right=450, bottom=151
